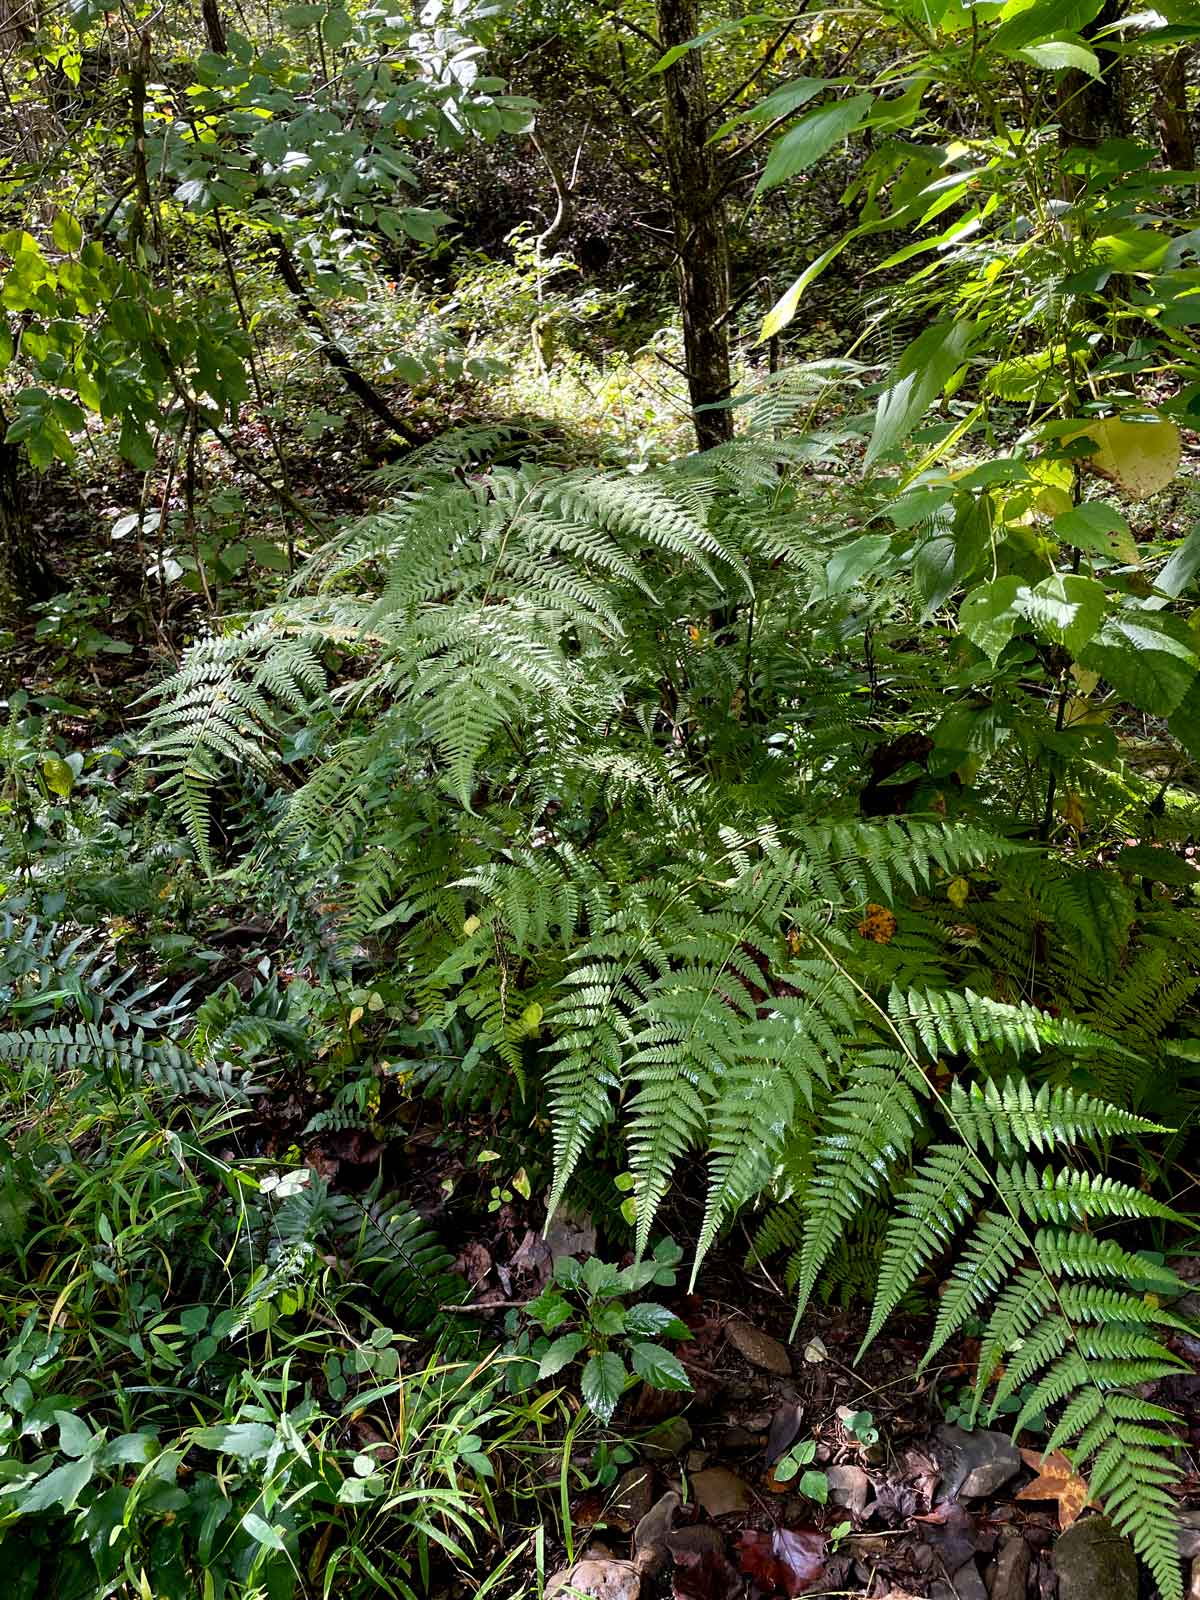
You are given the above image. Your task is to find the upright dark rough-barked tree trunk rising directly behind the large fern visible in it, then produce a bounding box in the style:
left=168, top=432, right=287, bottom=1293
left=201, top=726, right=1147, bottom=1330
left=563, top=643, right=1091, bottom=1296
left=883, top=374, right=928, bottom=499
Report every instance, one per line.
left=658, top=0, right=733, bottom=450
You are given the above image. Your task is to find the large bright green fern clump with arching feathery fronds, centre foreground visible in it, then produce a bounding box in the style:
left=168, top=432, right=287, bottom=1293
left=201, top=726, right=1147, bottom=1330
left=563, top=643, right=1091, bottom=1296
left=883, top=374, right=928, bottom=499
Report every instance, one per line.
left=152, top=440, right=1190, bottom=1595
